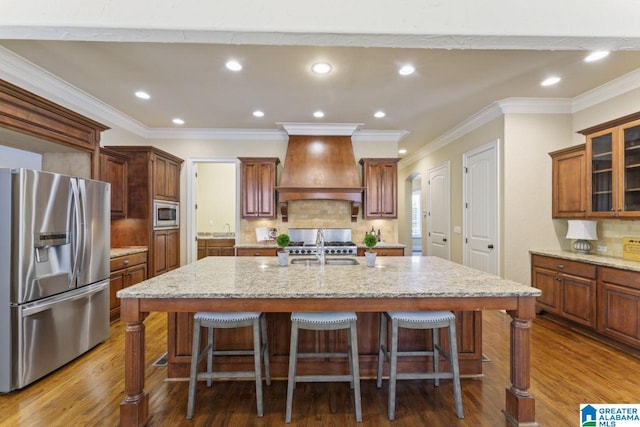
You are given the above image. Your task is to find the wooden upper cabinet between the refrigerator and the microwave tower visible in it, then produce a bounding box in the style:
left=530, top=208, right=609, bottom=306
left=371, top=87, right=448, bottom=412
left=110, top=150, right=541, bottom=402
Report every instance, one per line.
left=100, top=147, right=128, bottom=218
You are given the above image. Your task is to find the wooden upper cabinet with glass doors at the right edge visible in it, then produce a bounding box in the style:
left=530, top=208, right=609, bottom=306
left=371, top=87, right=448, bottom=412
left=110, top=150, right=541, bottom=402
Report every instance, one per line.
left=580, top=113, right=640, bottom=218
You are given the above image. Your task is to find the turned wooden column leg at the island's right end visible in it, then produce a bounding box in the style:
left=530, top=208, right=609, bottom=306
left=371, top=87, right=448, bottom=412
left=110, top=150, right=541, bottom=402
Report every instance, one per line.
left=503, top=297, right=539, bottom=427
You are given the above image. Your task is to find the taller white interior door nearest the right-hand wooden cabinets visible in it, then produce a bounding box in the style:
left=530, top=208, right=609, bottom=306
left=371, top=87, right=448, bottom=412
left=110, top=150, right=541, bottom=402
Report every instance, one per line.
left=463, top=140, right=500, bottom=275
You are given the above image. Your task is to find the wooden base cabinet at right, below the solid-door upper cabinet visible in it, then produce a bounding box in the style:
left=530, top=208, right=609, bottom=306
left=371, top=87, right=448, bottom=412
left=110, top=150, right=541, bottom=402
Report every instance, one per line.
left=531, top=255, right=596, bottom=328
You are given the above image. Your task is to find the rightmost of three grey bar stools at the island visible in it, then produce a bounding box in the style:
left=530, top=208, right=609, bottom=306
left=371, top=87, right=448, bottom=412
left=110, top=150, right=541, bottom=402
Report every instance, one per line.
left=377, top=311, right=464, bottom=420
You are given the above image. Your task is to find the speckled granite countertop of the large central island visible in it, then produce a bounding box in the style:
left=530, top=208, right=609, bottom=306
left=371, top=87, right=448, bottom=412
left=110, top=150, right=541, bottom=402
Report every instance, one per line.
left=117, top=257, right=541, bottom=298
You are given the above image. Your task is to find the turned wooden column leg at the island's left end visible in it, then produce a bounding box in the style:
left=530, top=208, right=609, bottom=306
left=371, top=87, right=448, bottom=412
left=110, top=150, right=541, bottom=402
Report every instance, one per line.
left=120, top=298, right=149, bottom=427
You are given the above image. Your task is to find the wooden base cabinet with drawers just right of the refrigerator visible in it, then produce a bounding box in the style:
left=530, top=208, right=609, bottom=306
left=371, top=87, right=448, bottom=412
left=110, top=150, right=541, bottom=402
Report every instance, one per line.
left=109, top=252, right=147, bottom=320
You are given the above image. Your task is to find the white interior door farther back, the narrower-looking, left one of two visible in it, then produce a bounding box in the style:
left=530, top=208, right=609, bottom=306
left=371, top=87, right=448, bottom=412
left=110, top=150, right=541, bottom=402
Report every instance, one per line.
left=427, top=162, right=451, bottom=260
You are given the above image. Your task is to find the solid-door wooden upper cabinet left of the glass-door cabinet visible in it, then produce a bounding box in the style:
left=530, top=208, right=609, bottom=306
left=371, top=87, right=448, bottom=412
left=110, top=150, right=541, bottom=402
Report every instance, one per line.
left=549, top=144, right=588, bottom=218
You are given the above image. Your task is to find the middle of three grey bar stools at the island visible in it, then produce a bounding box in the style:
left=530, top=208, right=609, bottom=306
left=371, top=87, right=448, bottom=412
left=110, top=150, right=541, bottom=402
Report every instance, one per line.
left=285, top=312, right=362, bottom=423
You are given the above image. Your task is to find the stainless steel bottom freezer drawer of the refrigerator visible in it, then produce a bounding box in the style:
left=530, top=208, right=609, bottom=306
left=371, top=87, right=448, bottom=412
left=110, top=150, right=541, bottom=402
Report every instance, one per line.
left=12, top=280, right=109, bottom=389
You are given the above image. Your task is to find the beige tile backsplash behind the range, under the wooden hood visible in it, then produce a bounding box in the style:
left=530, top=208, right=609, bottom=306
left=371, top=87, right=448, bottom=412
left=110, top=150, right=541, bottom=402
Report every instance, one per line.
left=238, top=200, right=398, bottom=243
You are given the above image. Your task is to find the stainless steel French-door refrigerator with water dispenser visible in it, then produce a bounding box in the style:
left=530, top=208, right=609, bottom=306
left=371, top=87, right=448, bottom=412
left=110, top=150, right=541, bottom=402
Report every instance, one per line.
left=0, top=169, right=111, bottom=392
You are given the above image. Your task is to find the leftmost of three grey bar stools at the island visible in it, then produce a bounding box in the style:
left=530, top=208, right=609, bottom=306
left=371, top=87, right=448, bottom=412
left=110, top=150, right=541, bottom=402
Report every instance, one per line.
left=187, top=312, right=271, bottom=419
